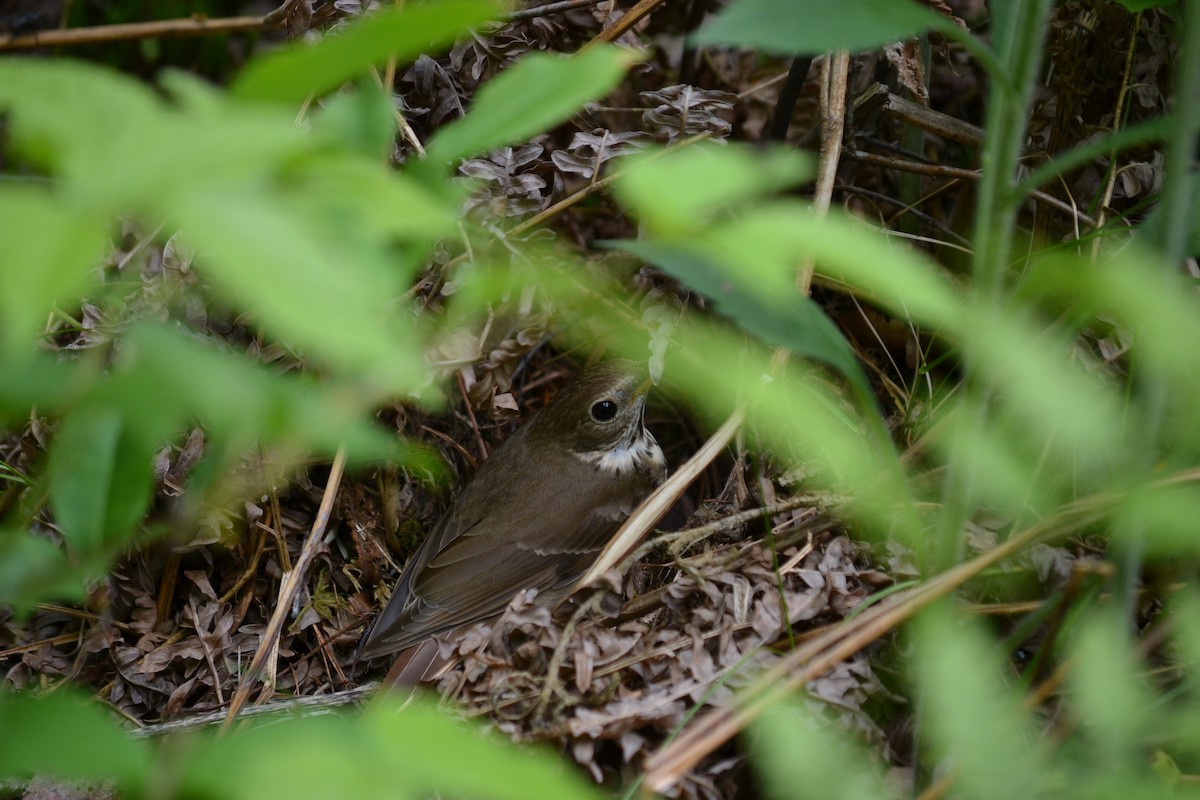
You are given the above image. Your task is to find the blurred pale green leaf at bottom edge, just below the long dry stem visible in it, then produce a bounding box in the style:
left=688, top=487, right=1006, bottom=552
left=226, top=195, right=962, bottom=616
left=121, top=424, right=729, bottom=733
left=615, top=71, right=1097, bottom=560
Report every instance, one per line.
left=749, top=698, right=900, bottom=800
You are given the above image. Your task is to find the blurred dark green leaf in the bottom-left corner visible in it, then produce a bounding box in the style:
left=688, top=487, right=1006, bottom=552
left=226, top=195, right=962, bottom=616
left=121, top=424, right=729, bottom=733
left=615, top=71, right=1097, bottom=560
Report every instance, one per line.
left=0, top=690, right=155, bottom=789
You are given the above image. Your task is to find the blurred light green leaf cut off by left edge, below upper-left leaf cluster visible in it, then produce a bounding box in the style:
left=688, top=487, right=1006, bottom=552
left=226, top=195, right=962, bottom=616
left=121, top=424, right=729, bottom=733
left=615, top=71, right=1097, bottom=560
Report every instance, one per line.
left=0, top=186, right=108, bottom=353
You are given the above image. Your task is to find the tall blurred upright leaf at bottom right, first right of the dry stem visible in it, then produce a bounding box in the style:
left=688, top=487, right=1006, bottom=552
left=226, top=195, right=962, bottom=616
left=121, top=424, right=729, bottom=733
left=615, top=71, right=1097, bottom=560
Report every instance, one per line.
left=913, top=606, right=1049, bottom=800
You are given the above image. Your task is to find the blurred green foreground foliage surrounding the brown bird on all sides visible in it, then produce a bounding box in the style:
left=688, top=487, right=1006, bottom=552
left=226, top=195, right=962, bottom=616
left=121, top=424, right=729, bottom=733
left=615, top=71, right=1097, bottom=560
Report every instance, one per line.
left=0, top=0, right=1200, bottom=798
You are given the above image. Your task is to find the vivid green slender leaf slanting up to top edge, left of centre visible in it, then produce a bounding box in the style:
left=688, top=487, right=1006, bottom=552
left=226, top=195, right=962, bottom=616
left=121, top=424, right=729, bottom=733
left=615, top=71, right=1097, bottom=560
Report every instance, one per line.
left=230, top=0, right=498, bottom=103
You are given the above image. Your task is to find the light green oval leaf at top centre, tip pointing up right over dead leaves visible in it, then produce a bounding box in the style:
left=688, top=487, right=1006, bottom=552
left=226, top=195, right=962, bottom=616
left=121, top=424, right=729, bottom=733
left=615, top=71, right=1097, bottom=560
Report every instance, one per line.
left=427, top=47, right=635, bottom=167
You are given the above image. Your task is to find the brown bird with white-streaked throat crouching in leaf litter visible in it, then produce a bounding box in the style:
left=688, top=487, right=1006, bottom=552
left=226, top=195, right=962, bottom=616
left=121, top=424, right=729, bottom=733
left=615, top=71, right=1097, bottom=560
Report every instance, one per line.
left=355, top=361, right=666, bottom=686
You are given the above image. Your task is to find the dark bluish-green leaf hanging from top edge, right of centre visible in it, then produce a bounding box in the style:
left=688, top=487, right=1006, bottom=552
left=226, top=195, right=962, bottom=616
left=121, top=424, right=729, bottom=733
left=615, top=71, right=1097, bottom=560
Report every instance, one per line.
left=694, top=0, right=938, bottom=55
